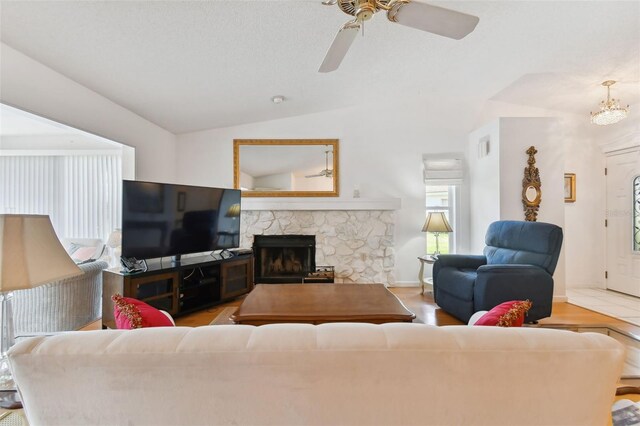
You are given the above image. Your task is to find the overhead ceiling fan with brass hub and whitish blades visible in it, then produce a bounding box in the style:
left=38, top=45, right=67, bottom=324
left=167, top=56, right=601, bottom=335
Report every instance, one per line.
left=318, top=0, right=479, bottom=73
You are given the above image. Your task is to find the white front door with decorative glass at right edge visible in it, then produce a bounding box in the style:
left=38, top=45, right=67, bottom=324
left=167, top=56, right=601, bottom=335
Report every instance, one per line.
left=606, top=150, right=640, bottom=296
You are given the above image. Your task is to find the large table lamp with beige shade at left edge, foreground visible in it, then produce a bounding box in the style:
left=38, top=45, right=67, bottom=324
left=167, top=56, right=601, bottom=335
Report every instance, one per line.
left=0, top=214, right=82, bottom=408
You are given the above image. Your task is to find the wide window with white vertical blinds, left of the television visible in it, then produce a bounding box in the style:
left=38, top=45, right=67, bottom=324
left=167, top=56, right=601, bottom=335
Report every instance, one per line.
left=0, top=155, right=122, bottom=241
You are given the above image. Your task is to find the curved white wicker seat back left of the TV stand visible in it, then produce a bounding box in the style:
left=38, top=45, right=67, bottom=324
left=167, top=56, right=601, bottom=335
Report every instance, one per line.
left=12, top=260, right=109, bottom=336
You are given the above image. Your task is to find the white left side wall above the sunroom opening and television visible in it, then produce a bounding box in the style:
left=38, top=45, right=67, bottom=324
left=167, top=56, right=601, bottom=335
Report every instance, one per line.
left=0, top=43, right=176, bottom=182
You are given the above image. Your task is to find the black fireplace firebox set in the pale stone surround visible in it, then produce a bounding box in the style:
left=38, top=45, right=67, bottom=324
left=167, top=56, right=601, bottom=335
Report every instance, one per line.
left=253, top=235, right=316, bottom=284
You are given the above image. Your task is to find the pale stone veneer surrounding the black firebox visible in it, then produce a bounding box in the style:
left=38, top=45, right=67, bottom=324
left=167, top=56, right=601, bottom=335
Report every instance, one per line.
left=240, top=210, right=395, bottom=285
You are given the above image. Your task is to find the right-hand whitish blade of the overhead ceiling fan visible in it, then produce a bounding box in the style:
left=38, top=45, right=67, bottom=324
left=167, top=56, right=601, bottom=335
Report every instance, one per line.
left=387, top=1, right=480, bottom=40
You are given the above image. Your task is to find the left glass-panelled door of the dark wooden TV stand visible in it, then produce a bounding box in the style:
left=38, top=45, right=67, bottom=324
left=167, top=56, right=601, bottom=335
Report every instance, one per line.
left=125, top=272, right=179, bottom=315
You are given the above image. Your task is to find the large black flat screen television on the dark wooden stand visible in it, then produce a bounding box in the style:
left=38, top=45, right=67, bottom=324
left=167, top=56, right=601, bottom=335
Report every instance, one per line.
left=122, top=180, right=240, bottom=259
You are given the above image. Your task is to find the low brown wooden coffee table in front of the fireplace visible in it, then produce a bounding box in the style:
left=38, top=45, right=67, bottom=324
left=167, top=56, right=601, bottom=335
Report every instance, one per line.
left=231, top=284, right=416, bottom=325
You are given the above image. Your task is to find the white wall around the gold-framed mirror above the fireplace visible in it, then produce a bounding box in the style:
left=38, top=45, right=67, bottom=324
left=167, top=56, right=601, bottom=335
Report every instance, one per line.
left=177, top=96, right=474, bottom=284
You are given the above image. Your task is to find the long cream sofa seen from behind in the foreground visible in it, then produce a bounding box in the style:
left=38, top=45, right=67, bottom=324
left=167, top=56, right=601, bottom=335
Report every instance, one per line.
left=9, top=323, right=624, bottom=426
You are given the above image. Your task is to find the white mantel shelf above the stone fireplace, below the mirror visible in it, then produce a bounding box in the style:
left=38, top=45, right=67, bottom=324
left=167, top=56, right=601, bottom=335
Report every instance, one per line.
left=242, top=197, right=401, bottom=210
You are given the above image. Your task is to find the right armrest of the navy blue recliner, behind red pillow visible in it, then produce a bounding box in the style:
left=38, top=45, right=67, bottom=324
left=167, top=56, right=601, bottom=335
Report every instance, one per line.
left=474, top=264, right=553, bottom=321
